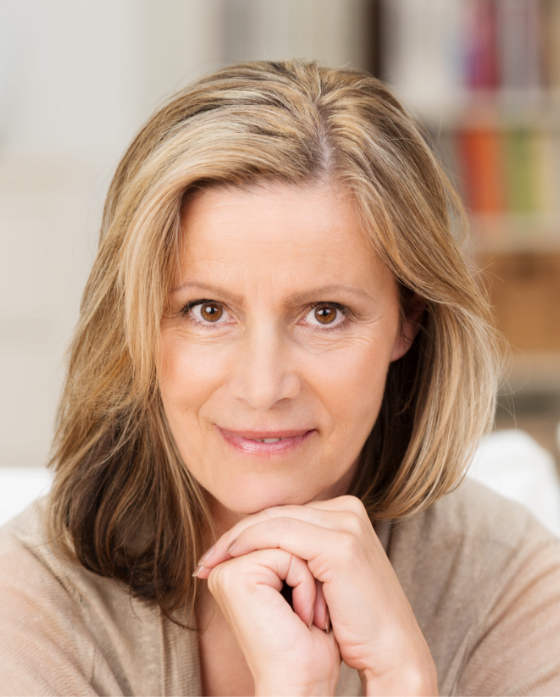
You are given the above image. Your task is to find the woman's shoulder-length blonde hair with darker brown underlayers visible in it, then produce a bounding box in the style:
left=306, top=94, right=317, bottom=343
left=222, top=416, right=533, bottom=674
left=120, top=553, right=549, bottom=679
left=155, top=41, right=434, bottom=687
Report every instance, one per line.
left=49, top=61, right=497, bottom=616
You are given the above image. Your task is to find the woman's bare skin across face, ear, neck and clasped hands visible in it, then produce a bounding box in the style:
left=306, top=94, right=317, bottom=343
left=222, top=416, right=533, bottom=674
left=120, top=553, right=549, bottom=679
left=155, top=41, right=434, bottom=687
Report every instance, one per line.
left=159, top=184, right=437, bottom=695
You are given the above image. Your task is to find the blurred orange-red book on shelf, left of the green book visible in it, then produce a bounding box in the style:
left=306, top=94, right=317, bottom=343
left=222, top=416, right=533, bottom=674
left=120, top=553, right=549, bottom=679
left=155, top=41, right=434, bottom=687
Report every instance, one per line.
left=457, top=129, right=506, bottom=214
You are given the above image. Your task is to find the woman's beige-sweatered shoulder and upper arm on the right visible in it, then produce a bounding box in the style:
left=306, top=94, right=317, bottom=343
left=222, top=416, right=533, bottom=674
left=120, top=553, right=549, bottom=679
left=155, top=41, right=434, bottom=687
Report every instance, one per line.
left=388, top=479, right=560, bottom=694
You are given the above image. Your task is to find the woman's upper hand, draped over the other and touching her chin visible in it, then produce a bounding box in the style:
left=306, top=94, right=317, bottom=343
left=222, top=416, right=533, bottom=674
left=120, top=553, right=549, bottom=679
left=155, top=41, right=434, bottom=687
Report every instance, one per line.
left=198, top=496, right=437, bottom=695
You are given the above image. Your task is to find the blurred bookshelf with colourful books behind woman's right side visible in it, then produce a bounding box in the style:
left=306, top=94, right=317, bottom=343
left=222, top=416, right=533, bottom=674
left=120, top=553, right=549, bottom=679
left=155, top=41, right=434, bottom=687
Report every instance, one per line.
left=377, top=0, right=560, bottom=394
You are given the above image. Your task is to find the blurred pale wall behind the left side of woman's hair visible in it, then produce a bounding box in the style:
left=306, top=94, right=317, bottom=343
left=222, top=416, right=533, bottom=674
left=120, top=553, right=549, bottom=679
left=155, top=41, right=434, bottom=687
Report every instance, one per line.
left=0, top=0, right=367, bottom=466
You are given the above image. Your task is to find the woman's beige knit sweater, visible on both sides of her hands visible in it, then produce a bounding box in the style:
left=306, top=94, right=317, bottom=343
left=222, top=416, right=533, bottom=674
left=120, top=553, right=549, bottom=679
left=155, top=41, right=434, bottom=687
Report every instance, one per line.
left=0, top=481, right=560, bottom=695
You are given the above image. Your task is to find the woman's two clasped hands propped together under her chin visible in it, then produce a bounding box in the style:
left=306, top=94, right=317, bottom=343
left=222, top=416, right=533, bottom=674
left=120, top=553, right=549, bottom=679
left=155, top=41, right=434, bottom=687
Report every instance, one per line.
left=195, top=496, right=437, bottom=695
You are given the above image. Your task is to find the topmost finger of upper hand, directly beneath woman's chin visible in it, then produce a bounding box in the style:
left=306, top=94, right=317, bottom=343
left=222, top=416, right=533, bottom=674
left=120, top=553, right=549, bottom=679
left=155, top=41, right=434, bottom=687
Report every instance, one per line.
left=193, top=496, right=373, bottom=578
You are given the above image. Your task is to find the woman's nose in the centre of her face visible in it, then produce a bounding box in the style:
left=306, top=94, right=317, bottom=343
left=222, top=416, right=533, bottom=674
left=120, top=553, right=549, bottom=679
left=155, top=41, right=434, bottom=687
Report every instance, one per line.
left=229, top=325, right=301, bottom=411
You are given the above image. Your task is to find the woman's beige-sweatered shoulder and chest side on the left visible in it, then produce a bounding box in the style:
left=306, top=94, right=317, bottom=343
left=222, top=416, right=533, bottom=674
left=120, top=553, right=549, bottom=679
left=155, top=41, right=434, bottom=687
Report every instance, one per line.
left=0, top=499, right=185, bottom=695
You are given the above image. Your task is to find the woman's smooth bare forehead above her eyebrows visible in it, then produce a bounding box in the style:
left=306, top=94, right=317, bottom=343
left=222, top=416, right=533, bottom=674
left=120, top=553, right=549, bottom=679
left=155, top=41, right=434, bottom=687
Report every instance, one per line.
left=180, top=183, right=388, bottom=290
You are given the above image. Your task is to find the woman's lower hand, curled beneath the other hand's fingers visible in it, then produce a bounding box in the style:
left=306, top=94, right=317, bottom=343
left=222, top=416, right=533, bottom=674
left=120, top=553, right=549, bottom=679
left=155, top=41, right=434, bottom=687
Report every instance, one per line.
left=201, top=549, right=340, bottom=695
